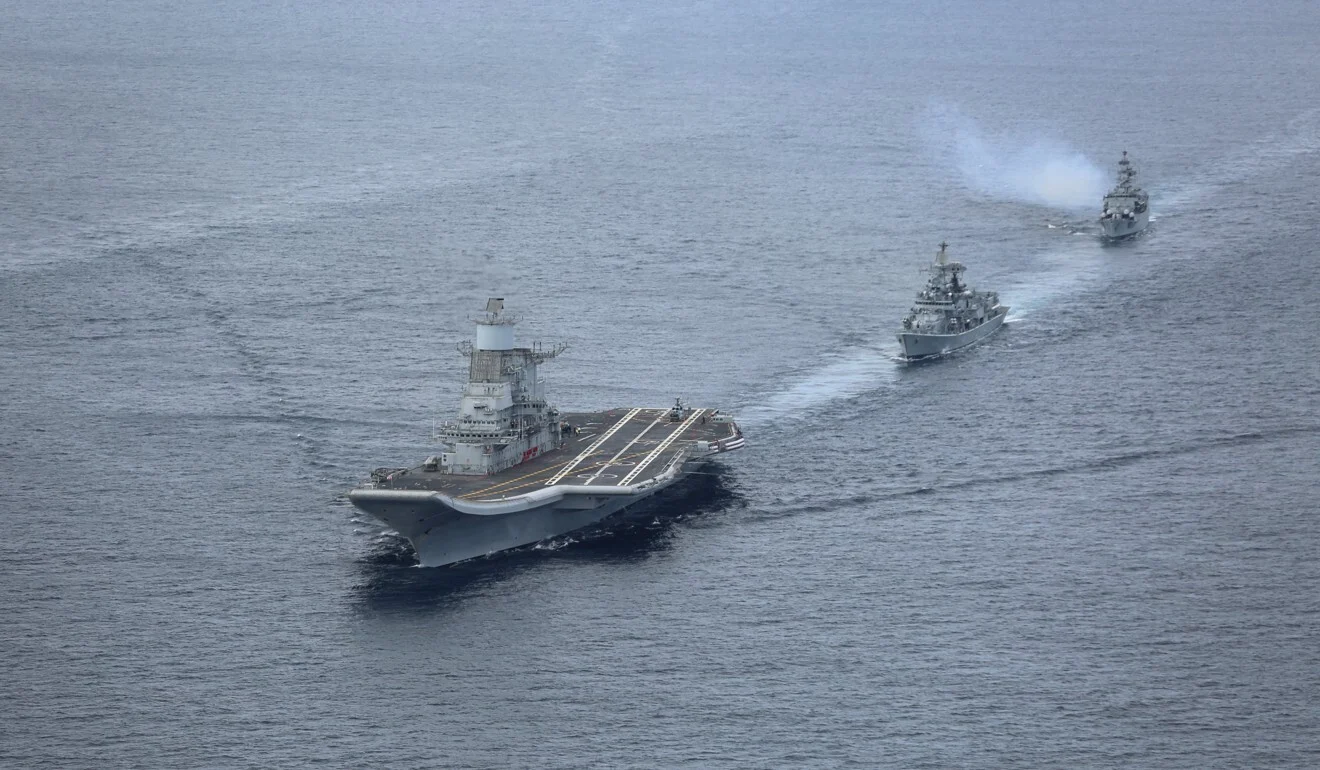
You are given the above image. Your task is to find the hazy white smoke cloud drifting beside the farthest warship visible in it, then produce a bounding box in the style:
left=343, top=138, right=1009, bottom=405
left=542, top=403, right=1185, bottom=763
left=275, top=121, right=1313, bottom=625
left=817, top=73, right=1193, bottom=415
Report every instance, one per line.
left=920, top=108, right=1109, bottom=209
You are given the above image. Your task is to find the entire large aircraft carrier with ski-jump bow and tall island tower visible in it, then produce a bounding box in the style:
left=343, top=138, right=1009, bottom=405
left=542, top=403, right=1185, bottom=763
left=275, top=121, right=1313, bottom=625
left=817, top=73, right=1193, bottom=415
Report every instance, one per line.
left=348, top=297, right=743, bottom=567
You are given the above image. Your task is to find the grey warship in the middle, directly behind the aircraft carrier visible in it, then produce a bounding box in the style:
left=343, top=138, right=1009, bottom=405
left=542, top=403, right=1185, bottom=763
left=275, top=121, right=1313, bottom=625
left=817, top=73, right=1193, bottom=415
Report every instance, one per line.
left=899, top=243, right=1008, bottom=361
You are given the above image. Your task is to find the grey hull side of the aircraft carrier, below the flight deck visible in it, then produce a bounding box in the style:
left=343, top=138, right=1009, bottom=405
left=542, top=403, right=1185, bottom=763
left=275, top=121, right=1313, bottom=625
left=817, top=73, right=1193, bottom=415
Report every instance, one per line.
left=352, top=461, right=704, bottom=567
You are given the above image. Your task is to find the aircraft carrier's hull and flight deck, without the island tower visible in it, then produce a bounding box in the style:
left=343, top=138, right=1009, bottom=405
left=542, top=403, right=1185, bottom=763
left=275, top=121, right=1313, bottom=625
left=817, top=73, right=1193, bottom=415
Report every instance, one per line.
left=348, top=407, right=744, bottom=567
